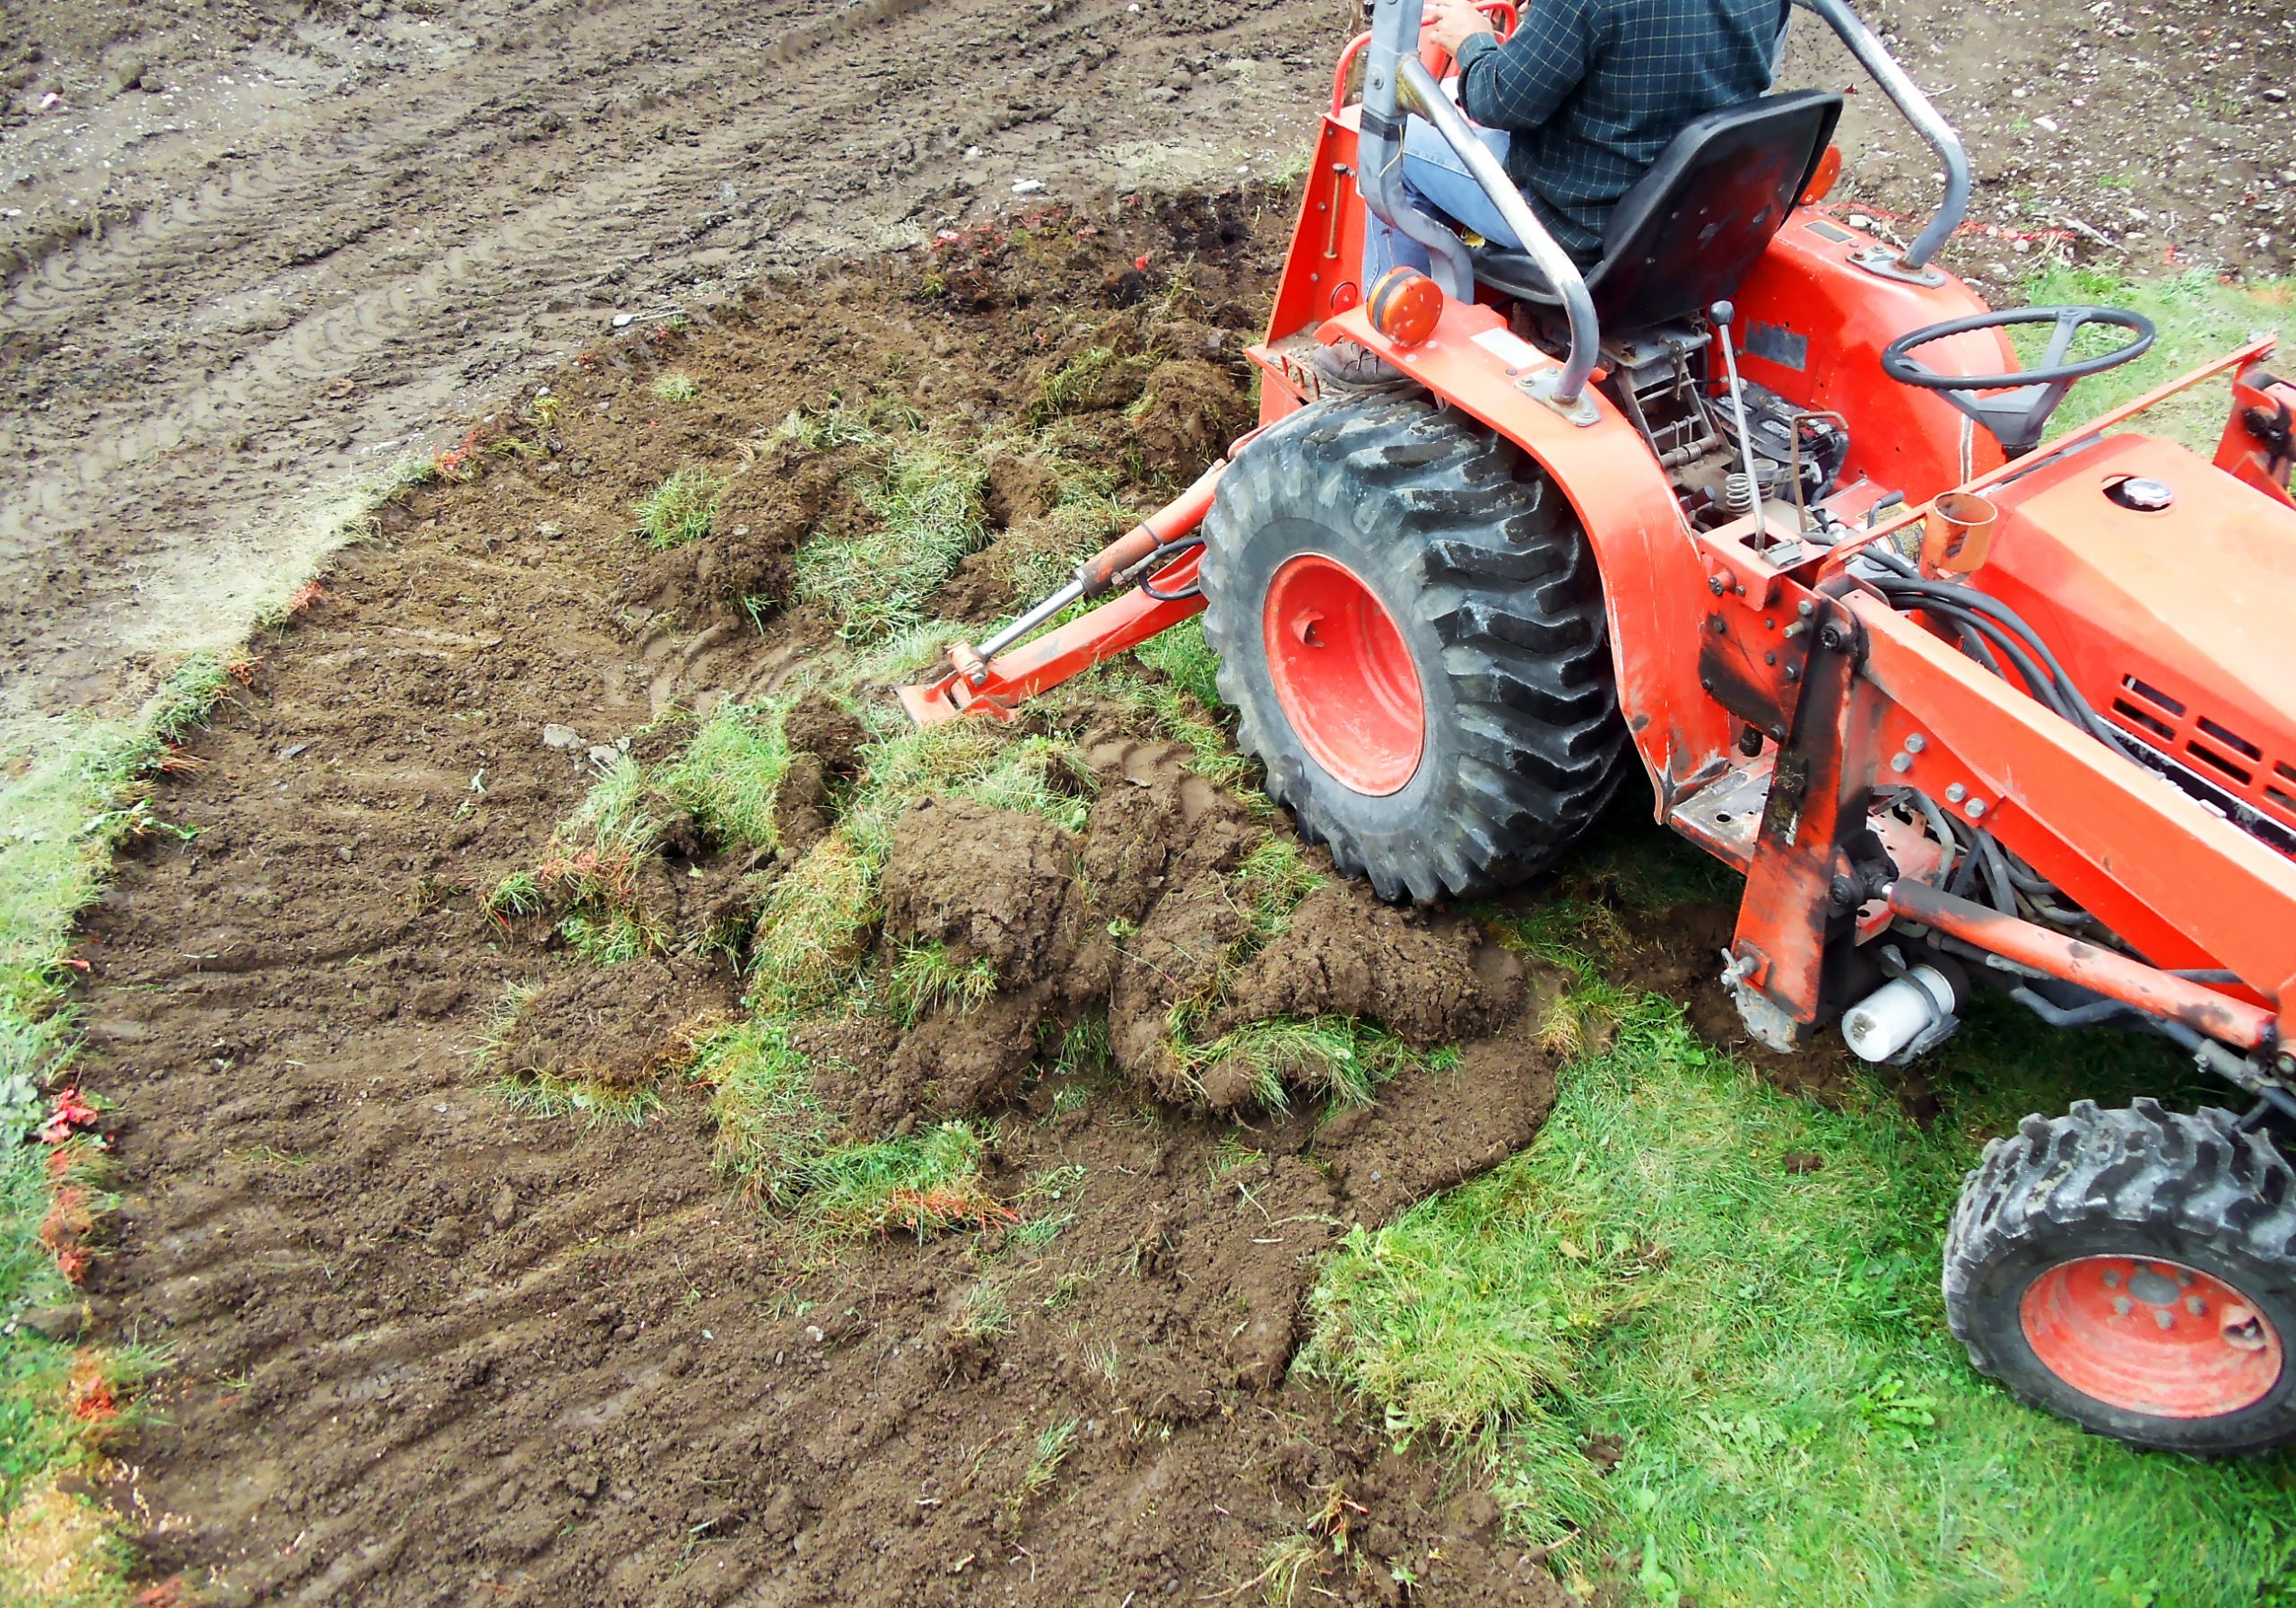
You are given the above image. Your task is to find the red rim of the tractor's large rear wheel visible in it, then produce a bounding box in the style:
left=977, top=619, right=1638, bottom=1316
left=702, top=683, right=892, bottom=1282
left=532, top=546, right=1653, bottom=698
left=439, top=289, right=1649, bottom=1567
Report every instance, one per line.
left=1263, top=553, right=1428, bottom=797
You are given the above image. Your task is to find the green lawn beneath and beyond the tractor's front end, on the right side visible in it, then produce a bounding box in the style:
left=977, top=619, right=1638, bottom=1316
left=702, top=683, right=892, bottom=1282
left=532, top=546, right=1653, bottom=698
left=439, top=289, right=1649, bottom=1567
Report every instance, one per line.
left=1302, top=271, right=2296, bottom=1608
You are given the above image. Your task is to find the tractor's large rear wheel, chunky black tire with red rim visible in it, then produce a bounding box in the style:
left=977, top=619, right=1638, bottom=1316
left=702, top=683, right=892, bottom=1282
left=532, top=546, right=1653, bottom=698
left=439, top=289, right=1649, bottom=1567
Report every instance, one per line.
left=1203, top=390, right=1628, bottom=900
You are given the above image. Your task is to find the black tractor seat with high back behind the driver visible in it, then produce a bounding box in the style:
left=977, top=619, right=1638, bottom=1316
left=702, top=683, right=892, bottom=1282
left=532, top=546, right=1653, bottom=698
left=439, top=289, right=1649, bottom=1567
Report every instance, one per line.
left=1474, top=90, right=1841, bottom=335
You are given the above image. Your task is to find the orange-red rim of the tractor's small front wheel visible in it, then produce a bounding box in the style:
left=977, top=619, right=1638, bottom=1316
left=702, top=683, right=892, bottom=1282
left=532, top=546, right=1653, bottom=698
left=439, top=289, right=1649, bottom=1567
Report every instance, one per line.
left=2018, top=1256, right=2287, bottom=1417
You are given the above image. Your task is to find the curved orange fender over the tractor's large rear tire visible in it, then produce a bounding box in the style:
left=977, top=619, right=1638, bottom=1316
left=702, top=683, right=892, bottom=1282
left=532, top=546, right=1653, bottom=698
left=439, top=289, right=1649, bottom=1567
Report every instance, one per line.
left=1318, top=301, right=1731, bottom=820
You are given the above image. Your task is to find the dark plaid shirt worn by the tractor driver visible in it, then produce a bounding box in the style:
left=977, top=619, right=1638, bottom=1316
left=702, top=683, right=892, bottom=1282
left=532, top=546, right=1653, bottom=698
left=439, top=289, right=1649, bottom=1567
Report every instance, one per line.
left=1458, top=0, right=1787, bottom=262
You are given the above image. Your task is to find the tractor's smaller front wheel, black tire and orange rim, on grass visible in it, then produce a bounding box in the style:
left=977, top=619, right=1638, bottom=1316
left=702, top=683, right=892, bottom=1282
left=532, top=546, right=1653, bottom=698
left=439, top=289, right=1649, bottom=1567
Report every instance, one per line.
left=1944, top=1100, right=2296, bottom=1456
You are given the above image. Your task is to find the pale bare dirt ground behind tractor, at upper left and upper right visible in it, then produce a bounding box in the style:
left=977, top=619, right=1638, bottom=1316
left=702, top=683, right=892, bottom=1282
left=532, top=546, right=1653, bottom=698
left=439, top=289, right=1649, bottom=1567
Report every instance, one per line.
left=0, top=0, right=2296, bottom=728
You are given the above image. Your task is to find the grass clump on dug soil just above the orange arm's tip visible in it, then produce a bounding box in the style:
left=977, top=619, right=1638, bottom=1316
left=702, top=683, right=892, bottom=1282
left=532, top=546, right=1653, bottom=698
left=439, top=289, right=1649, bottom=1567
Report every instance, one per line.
left=796, top=441, right=989, bottom=643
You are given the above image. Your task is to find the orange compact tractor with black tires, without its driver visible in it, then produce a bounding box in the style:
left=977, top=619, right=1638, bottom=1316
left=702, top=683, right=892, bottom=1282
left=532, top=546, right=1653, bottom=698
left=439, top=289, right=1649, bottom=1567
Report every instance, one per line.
left=905, top=0, right=2296, bottom=1452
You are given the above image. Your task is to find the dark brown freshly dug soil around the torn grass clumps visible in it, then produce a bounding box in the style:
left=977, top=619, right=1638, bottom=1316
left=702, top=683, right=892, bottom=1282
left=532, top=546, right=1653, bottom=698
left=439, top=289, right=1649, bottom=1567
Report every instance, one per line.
left=83, top=202, right=1561, bottom=1605
